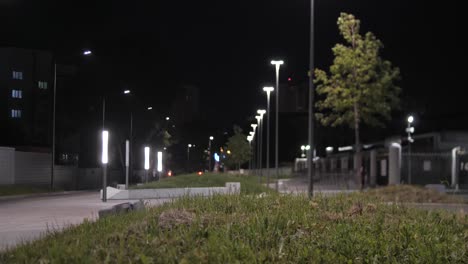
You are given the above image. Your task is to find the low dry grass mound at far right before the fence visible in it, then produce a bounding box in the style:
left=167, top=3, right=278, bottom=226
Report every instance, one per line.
left=366, top=185, right=464, bottom=203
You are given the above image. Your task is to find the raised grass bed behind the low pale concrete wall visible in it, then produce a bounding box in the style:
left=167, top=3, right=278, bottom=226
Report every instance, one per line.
left=131, top=173, right=273, bottom=194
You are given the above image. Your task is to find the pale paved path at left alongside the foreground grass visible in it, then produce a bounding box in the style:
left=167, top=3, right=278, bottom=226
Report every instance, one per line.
left=0, top=192, right=167, bottom=250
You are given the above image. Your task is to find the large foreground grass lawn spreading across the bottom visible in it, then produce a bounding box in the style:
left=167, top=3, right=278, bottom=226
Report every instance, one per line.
left=0, top=193, right=468, bottom=263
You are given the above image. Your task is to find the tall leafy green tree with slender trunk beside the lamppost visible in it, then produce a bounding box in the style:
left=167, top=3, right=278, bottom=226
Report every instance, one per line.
left=314, top=13, right=401, bottom=174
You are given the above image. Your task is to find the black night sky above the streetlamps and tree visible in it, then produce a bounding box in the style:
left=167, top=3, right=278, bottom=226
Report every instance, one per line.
left=0, top=0, right=460, bottom=136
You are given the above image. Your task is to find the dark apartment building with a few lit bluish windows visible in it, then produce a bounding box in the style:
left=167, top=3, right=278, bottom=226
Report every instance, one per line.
left=0, top=48, right=53, bottom=147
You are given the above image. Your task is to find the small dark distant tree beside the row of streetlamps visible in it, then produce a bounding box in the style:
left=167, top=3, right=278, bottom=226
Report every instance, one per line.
left=226, top=126, right=252, bottom=169
